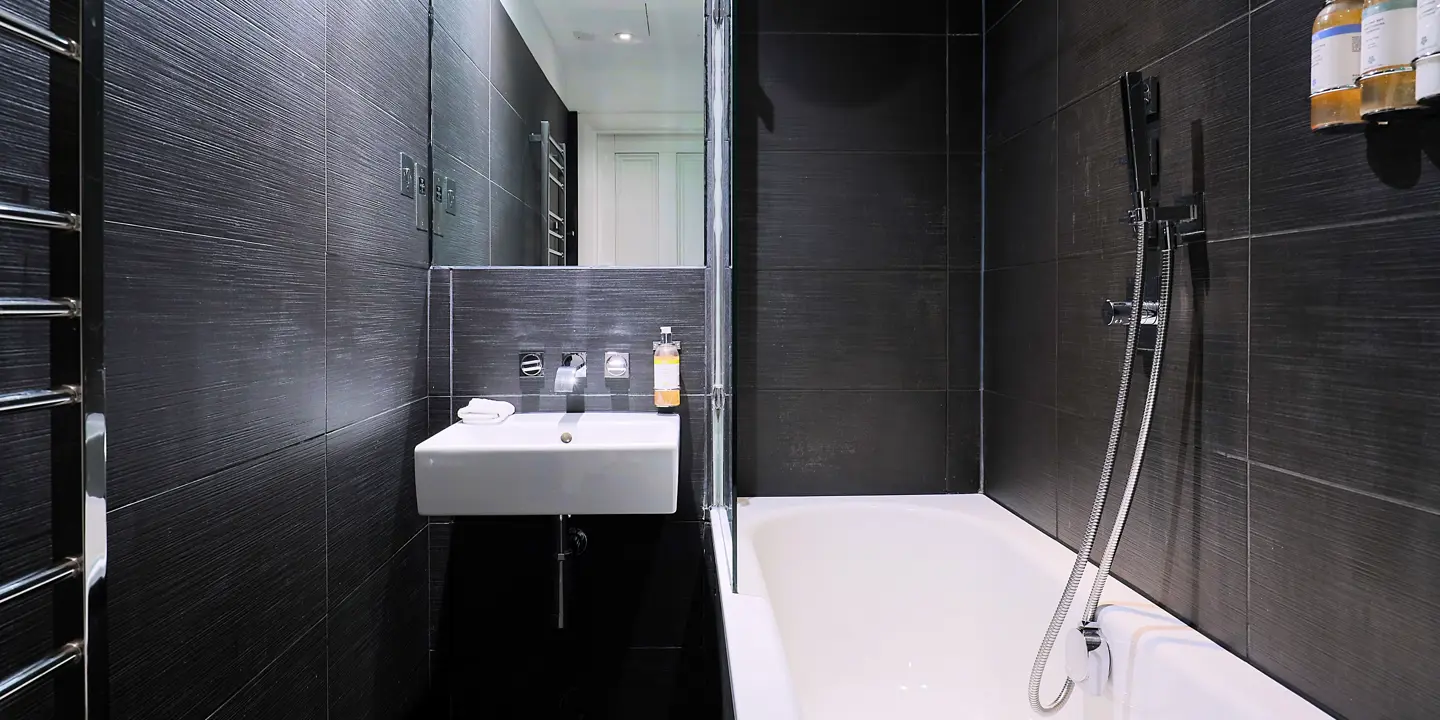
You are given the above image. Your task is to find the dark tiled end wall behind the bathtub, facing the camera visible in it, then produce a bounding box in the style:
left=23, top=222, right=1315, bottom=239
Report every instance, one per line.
left=734, top=3, right=984, bottom=495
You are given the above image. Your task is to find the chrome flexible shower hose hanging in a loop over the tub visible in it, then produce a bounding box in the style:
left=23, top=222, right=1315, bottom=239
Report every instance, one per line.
left=1030, top=220, right=1171, bottom=714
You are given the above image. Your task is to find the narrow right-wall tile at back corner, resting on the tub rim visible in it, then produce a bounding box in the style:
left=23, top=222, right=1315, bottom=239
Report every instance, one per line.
left=985, top=392, right=1058, bottom=536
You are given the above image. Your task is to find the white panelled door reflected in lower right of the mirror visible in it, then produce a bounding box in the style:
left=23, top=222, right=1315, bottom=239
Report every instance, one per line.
left=593, top=134, right=706, bottom=266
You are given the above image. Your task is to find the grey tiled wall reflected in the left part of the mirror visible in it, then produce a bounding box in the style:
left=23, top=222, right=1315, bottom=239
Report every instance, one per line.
left=431, top=0, right=569, bottom=266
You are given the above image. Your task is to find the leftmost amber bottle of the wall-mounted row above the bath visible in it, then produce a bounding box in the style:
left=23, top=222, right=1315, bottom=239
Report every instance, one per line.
left=1310, top=0, right=1365, bottom=132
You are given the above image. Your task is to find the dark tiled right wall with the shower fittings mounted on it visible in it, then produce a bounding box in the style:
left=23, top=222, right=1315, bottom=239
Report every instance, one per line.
left=984, top=0, right=1440, bottom=719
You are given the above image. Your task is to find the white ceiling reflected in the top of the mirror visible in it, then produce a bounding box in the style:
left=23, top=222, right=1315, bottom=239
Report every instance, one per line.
left=523, top=0, right=704, bottom=112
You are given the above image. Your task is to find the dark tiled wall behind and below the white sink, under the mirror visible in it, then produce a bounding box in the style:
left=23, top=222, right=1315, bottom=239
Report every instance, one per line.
left=429, top=268, right=720, bottom=719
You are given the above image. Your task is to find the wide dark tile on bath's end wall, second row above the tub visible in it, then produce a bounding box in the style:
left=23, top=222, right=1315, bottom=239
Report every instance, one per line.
left=734, top=271, right=949, bottom=390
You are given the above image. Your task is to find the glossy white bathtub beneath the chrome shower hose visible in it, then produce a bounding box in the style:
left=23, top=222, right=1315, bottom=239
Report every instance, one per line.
left=711, top=495, right=1329, bottom=720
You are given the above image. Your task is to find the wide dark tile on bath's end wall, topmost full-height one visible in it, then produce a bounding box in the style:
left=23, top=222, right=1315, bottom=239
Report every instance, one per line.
left=734, top=35, right=946, bottom=153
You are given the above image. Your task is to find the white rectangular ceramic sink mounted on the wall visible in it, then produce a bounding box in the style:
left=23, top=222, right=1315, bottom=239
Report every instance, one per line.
left=415, top=412, right=680, bottom=516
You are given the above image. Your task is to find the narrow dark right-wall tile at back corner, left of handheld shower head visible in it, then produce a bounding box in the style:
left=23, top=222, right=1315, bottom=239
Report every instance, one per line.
left=985, top=120, right=1059, bottom=269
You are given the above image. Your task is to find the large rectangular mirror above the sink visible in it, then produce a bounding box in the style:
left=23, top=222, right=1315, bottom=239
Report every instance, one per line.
left=422, top=0, right=706, bottom=266
